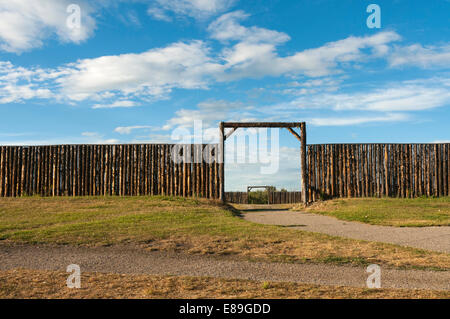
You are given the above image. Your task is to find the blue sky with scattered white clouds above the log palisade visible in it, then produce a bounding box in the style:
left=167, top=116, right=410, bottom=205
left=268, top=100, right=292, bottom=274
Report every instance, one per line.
left=0, top=0, right=450, bottom=190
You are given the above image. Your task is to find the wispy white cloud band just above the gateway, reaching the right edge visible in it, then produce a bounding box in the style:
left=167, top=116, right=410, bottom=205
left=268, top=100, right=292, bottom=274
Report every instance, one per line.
left=223, top=77, right=450, bottom=126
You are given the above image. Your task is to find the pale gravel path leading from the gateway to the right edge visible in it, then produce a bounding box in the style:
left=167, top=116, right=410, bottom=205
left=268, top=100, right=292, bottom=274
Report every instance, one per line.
left=243, top=210, right=450, bottom=253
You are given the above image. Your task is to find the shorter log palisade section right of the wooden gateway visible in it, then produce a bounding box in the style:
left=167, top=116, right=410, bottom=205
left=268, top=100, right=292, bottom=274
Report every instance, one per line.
left=307, top=143, right=450, bottom=201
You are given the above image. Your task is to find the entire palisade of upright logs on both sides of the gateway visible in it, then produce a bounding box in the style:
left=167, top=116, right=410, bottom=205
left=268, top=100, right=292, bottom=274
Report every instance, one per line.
left=0, top=144, right=450, bottom=202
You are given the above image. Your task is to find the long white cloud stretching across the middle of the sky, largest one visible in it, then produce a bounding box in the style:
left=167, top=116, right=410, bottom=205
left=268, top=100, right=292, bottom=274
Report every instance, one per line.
left=43, top=12, right=399, bottom=107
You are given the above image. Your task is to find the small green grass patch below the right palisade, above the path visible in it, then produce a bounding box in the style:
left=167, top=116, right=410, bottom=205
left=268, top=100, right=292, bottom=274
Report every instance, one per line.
left=302, top=197, right=450, bottom=227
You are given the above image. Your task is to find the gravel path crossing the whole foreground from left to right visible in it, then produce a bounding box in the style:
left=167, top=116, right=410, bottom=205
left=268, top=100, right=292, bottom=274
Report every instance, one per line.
left=0, top=245, right=450, bottom=290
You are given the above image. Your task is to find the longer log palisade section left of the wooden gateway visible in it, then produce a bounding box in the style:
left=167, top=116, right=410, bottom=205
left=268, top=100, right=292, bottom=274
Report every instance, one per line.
left=0, top=144, right=223, bottom=198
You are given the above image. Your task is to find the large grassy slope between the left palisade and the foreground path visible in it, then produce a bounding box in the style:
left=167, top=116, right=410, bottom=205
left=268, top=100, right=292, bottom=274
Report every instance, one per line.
left=0, top=196, right=450, bottom=270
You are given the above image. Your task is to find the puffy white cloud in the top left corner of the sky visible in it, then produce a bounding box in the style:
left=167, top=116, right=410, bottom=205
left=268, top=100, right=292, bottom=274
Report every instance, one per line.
left=0, top=0, right=95, bottom=53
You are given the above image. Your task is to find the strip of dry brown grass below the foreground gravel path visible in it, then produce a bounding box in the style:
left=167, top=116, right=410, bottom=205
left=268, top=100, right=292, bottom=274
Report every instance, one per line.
left=0, top=270, right=450, bottom=299
